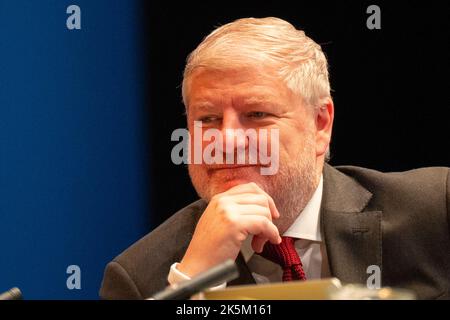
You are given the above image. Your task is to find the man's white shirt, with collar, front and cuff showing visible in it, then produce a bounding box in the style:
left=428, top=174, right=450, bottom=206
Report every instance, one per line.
left=167, top=176, right=323, bottom=289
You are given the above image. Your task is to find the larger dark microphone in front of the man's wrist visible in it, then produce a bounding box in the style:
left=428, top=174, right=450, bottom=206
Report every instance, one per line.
left=147, top=260, right=239, bottom=300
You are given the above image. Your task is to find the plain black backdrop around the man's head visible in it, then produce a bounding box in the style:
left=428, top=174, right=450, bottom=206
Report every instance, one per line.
left=142, top=0, right=450, bottom=226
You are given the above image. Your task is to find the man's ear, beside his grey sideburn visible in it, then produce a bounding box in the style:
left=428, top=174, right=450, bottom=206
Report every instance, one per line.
left=315, top=97, right=334, bottom=157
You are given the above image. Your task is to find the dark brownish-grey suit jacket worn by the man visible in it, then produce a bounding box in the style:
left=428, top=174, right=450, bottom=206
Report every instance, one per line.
left=100, top=165, right=450, bottom=299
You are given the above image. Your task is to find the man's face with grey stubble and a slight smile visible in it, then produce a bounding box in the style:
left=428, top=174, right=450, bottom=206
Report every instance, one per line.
left=186, top=67, right=318, bottom=230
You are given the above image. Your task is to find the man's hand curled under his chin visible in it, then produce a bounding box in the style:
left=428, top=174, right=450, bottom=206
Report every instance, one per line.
left=178, top=182, right=281, bottom=277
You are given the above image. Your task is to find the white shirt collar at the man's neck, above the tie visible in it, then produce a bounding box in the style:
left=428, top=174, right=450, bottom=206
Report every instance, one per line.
left=241, top=175, right=323, bottom=262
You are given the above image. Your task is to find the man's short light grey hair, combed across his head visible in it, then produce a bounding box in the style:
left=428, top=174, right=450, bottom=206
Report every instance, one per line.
left=182, top=17, right=331, bottom=107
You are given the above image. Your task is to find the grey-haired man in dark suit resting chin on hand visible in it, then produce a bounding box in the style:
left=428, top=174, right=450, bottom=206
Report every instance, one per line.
left=100, top=18, right=450, bottom=299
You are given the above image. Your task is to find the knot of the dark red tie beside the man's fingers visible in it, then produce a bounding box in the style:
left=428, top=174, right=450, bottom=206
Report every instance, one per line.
left=260, top=237, right=301, bottom=269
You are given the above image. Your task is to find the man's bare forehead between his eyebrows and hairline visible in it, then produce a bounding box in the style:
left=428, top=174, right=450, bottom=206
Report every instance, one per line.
left=187, top=67, right=292, bottom=105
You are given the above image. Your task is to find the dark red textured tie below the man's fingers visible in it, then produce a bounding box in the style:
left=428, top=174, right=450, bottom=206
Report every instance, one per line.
left=260, top=237, right=306, bottom=281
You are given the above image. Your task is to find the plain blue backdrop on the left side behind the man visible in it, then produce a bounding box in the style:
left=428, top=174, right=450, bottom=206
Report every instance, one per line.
left=0, top=0, right=150, bottom=299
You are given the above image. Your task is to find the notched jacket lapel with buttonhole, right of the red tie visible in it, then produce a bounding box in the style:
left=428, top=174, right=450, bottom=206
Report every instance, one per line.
left=321, top=165, right=382, bottom=283
